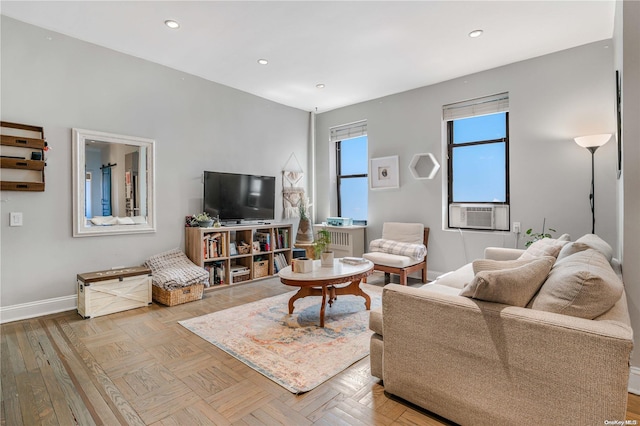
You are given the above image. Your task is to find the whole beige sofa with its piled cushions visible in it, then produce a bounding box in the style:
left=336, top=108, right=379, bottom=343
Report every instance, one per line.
left=370, top=235, right=633, bottom=425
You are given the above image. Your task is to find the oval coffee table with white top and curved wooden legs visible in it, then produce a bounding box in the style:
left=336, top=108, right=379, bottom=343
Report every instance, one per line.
left=278, top=259, right=373, bottom=327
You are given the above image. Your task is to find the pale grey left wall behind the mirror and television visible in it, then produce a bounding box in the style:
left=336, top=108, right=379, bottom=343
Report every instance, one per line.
left=0, top=16, right=309, bottom=314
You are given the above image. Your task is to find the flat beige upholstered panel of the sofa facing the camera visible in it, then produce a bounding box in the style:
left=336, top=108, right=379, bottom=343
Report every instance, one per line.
left=382, top=284, right=633, bottom=424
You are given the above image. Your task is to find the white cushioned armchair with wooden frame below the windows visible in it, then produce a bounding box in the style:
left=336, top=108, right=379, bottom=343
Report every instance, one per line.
left=363, top=222, right=429, bottom=285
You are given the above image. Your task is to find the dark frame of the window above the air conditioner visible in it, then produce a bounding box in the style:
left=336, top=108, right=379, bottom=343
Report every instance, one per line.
left=447, top=111, right=511, bottom=208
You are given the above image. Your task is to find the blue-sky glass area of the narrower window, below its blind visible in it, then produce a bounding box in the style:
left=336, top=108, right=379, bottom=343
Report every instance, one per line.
left=339, top=135, right=369, bottom=220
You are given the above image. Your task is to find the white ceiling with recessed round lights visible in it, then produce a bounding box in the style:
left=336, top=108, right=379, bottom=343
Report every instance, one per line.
left=0, top=0, right=615, bottom=112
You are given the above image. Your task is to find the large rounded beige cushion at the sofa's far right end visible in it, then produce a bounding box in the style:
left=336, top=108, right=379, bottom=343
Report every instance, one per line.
left=529, top=248, right=624, bottom=319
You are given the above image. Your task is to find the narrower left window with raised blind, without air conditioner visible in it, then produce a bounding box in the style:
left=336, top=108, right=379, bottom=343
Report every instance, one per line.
left=330, top=121, right=369, bottom=224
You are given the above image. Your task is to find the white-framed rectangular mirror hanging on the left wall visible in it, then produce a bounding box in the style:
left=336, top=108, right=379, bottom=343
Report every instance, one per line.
left=73, top=129, right=156, bottom=237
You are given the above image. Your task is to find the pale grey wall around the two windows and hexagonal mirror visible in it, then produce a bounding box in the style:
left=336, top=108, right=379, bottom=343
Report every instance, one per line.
left=315, top=40, right=618, bottom=276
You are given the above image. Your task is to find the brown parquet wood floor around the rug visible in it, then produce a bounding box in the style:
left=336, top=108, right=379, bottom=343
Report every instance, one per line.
left=0, top=277, right=640, bottom=426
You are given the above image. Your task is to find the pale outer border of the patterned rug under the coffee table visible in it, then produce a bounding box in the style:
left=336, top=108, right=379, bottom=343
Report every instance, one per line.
left=178, top=283, right=382, bottom=394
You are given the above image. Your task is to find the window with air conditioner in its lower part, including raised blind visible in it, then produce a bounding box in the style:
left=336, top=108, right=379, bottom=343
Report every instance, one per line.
left=443, top=93, right=509, bottom=229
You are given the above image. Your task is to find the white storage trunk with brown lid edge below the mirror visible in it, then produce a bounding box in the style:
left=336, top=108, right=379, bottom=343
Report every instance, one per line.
left=78, top=266, right=151, bottom=318
